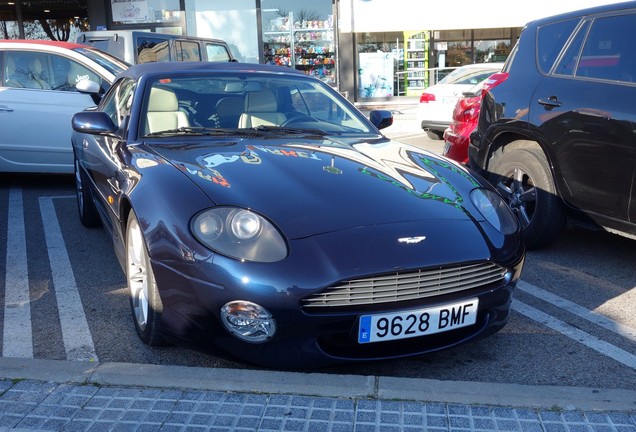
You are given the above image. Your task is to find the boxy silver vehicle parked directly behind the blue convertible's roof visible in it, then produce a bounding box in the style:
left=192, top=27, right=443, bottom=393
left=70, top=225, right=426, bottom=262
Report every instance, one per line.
left=76, top=30, right=236, bottom=64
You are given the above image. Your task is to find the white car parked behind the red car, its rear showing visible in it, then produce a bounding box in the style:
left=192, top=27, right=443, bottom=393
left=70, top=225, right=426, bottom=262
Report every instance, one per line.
left=417, top=63, right=503, bottom=139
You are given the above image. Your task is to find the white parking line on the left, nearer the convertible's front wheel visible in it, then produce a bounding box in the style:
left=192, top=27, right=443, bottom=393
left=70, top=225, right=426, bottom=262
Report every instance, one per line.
left=40, top=196, right=98, bottom=361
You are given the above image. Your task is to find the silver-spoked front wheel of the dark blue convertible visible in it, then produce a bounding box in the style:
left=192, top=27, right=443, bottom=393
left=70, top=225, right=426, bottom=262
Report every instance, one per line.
left=126, top=212, right=164, bottom=346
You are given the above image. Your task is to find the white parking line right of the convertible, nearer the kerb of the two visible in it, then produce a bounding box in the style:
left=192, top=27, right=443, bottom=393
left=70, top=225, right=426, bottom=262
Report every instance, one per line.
left=512, top=300, right=636, bottom=369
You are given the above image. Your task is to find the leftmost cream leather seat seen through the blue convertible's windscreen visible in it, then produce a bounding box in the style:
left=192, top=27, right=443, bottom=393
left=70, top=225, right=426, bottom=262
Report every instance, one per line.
left=146, top=87, right=190, bottom=133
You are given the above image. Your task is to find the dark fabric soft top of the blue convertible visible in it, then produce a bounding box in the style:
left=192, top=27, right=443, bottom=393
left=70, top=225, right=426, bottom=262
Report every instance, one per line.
left=119, top=62, right=306, bottom=80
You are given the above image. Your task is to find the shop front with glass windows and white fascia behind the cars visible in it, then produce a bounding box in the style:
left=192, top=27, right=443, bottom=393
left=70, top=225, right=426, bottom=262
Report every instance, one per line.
left=89, top=0, right=628, bottom=103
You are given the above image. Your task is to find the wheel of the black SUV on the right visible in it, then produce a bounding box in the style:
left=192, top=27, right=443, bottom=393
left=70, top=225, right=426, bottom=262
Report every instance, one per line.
left=489, top=147, right=566, bottom=249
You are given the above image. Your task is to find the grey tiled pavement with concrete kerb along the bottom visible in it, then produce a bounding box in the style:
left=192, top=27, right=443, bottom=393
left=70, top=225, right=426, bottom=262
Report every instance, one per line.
left=0, top=358, right=636, bottom=432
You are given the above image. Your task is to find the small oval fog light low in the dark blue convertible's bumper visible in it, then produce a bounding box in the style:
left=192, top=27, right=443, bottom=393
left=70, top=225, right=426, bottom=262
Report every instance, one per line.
left=221, top=300, right=276, bottom=342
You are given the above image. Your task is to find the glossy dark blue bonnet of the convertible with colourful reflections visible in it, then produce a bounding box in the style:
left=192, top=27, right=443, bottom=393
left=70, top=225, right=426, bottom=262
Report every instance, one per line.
left=147, top=137, right=479, bottom=239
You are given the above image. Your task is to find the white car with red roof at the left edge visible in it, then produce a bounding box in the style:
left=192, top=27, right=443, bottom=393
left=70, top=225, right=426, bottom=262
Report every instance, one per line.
left=0, top=40, right=128, bottom=173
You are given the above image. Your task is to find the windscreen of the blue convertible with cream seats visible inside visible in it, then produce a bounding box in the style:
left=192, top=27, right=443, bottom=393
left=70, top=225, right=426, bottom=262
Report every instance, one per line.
left=141, top=79, right=368, bottom=134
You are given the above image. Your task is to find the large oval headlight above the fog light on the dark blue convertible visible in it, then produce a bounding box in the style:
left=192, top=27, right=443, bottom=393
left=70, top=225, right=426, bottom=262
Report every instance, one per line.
left=191, top=207, right=287, bottom=262
